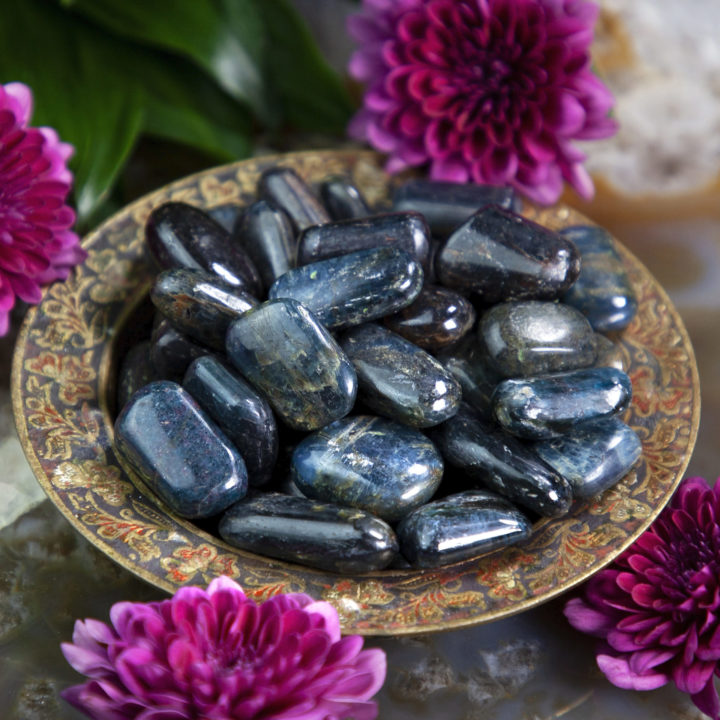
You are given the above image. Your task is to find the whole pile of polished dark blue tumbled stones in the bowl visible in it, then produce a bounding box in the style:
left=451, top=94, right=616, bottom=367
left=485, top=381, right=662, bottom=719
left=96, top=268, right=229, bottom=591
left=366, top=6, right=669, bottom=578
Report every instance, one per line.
left=115, top=168, right=641, bottom=573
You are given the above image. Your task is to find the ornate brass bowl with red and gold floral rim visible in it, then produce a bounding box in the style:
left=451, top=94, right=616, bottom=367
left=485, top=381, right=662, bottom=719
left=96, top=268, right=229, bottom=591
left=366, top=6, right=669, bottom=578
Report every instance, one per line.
left=12, top=151, right=700, bottom=635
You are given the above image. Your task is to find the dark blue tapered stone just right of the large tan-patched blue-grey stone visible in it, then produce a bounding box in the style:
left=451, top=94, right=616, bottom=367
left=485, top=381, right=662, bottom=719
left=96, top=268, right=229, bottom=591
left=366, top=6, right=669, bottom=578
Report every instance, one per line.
left=340, top=323, right=462, bottom=427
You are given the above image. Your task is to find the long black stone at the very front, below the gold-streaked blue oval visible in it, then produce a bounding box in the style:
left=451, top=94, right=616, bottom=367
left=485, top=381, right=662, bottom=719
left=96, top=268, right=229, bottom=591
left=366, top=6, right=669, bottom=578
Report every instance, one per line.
left=219, top=493, right=398, bottom=573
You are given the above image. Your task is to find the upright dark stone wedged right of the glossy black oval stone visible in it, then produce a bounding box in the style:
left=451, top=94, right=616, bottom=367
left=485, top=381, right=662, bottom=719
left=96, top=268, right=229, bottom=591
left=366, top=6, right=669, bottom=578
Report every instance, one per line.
left=233, top=200, right=296, bottom=288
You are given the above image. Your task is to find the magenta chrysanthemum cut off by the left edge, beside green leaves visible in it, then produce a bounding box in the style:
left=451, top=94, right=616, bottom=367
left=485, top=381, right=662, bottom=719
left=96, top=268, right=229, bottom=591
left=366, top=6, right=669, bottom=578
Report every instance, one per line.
left=0, top=83, right=85, bottom=335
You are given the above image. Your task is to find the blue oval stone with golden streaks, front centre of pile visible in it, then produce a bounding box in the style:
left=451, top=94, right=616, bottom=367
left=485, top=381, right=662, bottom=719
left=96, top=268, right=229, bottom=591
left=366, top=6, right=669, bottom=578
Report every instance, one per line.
left=292, top=415, right=443, bottom=522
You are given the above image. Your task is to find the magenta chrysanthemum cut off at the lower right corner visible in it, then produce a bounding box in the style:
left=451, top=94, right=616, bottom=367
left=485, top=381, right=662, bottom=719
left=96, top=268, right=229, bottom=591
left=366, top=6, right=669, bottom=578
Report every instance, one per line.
left=565, top=478, right=720, bottom=720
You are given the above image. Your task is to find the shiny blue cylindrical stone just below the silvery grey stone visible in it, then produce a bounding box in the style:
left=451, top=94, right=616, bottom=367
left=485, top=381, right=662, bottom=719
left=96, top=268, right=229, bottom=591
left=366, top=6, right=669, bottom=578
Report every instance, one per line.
left=492, top=367, right=632, bottom=440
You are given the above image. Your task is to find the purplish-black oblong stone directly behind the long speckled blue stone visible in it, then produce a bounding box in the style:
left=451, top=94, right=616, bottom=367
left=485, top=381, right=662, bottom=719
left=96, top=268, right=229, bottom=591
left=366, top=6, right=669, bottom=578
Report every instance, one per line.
left=298, top=213, right=430, bottom=268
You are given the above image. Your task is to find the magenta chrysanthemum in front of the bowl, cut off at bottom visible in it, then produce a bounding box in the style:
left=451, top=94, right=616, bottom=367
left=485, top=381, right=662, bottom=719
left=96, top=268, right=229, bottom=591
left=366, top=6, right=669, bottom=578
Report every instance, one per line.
left=62, top=577, right=386, bottom=720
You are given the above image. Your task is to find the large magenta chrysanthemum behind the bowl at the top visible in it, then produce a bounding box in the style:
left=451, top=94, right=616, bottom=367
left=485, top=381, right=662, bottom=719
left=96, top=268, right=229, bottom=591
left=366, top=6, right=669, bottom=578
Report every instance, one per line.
left=349, top=0, right=617, bottom=203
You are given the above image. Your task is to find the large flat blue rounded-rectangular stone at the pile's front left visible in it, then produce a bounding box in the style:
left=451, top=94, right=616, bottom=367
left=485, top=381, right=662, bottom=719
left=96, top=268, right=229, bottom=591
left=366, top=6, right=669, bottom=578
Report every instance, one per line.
left=115, top=380, right=247, bottom=518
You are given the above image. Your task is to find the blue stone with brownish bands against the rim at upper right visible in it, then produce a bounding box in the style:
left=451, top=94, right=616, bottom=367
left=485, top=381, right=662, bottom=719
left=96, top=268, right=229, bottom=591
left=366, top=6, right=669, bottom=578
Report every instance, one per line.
left=561, top=225, right=637, bottom=332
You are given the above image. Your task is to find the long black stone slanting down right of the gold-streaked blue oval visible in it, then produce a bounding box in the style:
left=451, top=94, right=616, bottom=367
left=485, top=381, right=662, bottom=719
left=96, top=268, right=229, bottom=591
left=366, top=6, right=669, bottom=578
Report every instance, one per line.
left=431, top=405, right=572, bottom=517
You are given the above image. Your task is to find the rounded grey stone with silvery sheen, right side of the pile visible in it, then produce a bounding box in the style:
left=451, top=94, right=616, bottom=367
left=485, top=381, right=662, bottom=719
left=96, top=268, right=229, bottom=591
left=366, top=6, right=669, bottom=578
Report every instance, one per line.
left=479, top=301, right=597, bottom=377
